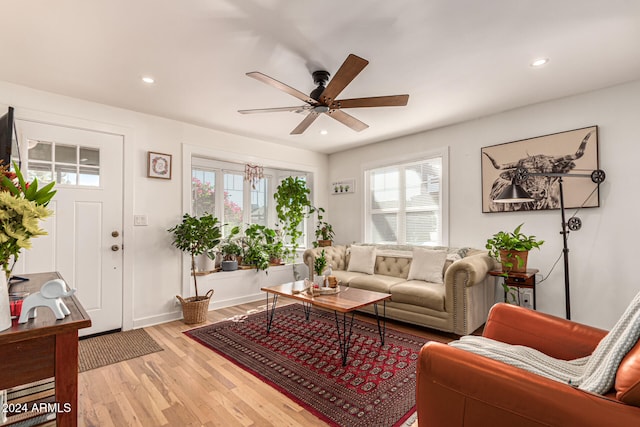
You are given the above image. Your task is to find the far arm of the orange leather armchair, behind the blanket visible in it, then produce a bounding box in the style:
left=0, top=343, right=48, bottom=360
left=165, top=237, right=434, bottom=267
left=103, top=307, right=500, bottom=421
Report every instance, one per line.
left=482, top=303, right=607, bottom=360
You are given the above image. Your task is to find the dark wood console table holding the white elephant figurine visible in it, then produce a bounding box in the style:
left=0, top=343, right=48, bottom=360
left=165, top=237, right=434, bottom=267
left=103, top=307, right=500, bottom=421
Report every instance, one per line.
left=0, top=273, right=91, bottom=426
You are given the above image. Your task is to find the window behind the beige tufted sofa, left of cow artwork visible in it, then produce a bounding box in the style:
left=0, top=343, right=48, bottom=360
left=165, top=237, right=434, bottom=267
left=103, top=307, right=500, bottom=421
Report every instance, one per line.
left=365, top=153, right=448, bottom=245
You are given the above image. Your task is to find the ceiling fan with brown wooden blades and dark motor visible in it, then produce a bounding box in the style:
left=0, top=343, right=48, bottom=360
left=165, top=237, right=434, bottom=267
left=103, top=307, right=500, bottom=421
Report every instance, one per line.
left=238, top=54, right=409, bottom=135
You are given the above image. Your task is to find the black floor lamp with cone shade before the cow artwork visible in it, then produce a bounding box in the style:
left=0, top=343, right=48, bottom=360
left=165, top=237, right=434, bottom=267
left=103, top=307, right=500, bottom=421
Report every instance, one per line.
left=493, top=168, right=605, bottom=319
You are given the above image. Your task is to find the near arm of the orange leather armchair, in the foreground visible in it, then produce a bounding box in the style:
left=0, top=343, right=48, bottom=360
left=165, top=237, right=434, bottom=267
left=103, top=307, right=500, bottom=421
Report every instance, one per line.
left=416, top=342, right=640, bottom=427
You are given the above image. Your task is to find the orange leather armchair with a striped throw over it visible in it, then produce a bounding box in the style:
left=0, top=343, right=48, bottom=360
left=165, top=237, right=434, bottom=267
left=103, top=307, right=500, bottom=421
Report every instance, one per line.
left=416, top=303, right=640, bottom=427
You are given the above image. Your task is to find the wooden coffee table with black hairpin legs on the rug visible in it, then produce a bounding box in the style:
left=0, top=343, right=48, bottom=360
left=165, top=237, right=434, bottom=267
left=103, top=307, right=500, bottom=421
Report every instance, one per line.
left=261, top=280, right=391, bottom=366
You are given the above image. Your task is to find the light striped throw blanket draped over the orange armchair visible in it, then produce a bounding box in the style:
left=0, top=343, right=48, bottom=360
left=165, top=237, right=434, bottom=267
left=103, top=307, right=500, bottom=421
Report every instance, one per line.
left=449, top=293, right=640, bottom=394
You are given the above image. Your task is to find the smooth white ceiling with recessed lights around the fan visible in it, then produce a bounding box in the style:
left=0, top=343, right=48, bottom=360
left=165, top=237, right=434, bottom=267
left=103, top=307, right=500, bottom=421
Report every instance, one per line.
left=0, top=0, right=640, bottom=153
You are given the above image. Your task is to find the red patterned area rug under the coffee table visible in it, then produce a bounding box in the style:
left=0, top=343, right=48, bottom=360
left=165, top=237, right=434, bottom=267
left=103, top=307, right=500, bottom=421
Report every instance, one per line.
left=185, top=304, right=426, bottom=427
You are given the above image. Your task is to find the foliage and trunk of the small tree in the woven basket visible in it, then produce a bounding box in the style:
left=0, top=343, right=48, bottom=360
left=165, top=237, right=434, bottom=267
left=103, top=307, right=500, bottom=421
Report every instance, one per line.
left=167, top=213, right=222, bottom=298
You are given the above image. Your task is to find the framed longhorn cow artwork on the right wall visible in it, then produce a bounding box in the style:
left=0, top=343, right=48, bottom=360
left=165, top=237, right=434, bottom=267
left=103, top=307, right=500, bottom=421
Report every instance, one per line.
left=481, top=126, right=600, bottom=213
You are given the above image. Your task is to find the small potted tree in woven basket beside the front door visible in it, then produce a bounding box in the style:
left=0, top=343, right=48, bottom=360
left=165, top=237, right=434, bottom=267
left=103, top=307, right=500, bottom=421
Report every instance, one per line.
left=167, top=213, right=222, bottom=324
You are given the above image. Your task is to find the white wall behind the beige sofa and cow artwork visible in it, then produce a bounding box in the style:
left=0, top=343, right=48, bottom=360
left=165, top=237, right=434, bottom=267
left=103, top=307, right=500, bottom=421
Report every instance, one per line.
left=328, top=81, right=640, bottom=329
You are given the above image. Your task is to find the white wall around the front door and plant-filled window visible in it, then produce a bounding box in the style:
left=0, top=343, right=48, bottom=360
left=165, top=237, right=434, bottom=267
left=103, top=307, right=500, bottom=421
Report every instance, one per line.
left=0, top=81, right=328, bottom=328
